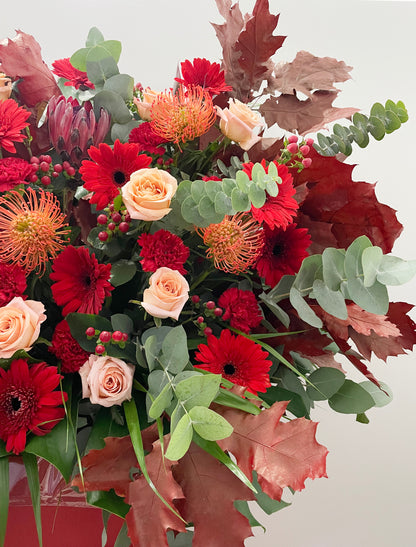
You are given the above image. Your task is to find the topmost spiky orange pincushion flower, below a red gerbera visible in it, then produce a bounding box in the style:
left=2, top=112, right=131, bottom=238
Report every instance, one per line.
left=151, top=86, right=216, bottom=144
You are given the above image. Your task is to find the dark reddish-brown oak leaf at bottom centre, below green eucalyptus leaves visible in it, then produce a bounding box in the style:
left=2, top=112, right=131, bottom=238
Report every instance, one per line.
left=173, top=443, right=255, bottom=547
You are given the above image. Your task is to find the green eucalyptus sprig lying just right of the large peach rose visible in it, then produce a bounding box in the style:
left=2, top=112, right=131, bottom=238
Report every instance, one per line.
left=175, top=163, right=282, bottom=228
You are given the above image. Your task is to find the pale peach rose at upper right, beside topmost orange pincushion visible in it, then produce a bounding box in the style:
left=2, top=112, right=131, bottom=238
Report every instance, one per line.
left=216, top=99, right=265, bottom=150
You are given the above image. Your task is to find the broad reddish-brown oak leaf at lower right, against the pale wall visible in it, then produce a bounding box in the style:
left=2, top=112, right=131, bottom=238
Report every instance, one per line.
left=215, top=402, right=328, bottom=500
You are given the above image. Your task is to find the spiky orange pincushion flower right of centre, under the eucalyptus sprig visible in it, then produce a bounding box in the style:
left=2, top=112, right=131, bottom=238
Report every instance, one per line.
left=197, top=213, right=264, bottom=273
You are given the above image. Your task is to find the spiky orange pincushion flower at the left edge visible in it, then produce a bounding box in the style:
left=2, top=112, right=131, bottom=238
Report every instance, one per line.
left=0, top=188, right=70, bottom=275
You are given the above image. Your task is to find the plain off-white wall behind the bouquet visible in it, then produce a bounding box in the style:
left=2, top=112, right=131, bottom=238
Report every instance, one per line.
left=0, top=0, right=416, bottom=547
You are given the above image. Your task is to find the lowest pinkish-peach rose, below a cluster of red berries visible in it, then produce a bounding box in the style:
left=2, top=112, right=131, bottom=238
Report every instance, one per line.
left=78, top=355, right=134, bottom=406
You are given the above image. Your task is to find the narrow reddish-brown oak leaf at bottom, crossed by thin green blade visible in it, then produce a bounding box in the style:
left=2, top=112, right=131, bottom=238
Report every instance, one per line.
left=126, top=440, right=186, bottom=547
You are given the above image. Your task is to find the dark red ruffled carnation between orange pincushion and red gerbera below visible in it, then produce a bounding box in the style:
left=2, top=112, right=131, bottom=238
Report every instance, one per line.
left=218, top=287, right=263, bottom=334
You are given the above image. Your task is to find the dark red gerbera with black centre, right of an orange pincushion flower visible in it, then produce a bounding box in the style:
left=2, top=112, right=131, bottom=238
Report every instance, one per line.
left=256, top=224, right=311, bottom=287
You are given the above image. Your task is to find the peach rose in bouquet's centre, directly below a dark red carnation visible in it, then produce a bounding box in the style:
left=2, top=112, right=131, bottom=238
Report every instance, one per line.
left=141, top=267, right=189, bottom=321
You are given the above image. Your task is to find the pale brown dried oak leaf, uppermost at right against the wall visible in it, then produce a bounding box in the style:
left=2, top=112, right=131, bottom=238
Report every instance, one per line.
left=273, top=51, right=352, bottom=97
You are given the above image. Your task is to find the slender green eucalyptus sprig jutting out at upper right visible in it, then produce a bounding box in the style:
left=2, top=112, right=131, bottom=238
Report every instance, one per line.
left=314, top=100, right=409, bottom=156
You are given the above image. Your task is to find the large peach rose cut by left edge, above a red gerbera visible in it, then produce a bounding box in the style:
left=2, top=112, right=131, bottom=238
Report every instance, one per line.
left=0, top=296, right=46, bottom=359
